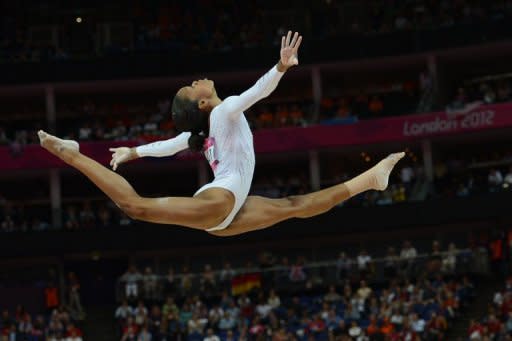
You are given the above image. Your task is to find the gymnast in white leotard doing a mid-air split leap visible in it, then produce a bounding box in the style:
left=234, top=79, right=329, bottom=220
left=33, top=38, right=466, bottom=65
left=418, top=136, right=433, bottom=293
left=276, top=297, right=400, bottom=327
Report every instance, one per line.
left=39, top=32, right=404, bottom=236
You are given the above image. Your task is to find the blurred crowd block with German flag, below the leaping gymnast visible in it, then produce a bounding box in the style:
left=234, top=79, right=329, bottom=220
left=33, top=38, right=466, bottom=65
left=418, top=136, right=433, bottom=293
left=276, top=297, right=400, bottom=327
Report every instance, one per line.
left=115, top=241, right=476, bottom=341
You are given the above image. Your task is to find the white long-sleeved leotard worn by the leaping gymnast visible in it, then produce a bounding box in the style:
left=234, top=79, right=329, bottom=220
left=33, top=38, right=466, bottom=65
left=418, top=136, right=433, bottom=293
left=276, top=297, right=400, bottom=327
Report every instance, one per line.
left=137, top=67, right=283, bottom=231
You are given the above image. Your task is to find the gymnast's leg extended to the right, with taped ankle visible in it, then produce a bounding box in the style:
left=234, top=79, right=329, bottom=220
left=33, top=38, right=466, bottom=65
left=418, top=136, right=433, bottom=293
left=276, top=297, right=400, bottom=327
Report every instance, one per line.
left=210, top=153, right=405, bottom=236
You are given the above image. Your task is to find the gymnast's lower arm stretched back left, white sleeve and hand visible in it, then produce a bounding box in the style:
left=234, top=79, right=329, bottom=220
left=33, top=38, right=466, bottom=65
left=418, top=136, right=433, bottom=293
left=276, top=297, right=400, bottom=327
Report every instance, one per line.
left=110, top=132, right=190, bottom=170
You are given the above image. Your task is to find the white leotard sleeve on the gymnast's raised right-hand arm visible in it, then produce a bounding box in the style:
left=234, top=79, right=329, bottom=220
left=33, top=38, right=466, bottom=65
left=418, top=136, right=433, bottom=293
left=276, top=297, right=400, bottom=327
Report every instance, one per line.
left=219, top=66, right=284, bottom=119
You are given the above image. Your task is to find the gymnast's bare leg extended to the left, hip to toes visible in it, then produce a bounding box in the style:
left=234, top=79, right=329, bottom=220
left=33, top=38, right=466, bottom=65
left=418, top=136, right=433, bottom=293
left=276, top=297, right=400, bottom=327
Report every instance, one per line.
left=38, top=131, right=234, bottom=230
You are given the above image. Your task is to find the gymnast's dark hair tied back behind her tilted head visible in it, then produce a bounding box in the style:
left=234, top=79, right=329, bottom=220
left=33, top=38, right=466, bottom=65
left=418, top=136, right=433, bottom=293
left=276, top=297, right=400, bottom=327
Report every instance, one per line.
left=172, top=95, right=209, bottom=152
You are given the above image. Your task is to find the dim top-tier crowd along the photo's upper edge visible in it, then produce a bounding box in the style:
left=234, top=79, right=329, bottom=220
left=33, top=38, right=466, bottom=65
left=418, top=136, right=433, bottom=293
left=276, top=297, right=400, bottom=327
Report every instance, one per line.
left=0, top=0, right=512, bottom=62
